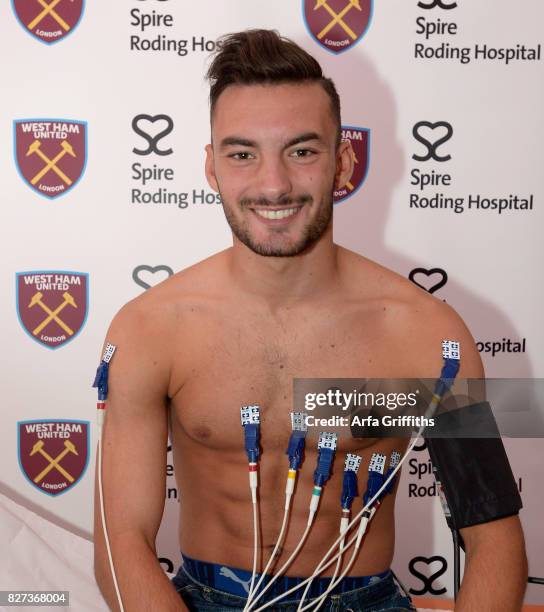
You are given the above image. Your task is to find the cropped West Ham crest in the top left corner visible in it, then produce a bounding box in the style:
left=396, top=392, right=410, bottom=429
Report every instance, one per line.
left=11, top=0, right=85, bottom=45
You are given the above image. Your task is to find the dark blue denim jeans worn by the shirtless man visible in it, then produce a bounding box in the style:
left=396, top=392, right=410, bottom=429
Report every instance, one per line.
left=172, top=565, right=416, bottom=612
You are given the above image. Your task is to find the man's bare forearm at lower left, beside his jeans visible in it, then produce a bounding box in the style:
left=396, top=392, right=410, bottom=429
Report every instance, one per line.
left=95, top=534, right=187, bottom=612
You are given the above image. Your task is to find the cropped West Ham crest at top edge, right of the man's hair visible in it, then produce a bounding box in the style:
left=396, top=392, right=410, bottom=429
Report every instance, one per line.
left=302, top=0, right=372, bottom=53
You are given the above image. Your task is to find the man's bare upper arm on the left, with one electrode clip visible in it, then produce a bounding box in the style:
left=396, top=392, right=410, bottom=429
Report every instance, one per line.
left=95, top=303, right=169, bottom=558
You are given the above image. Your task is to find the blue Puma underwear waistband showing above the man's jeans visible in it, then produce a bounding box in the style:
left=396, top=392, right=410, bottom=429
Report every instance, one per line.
left=182, top=553, right=390, bottom=603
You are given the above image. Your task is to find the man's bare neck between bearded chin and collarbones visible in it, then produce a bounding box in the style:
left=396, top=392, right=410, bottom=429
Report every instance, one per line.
left=229, top=224, right=338, bottom=308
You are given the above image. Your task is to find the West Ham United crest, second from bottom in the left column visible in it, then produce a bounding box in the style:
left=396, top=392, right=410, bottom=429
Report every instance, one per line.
left=16, top=270, right=89, bottom=349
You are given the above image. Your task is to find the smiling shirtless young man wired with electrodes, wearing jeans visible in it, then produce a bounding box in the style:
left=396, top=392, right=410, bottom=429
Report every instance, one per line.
left=95, top=31, right=526, bottom=612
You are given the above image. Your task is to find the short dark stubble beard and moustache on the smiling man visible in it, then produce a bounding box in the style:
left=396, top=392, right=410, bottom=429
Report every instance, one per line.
left=219, top=189, right=333, bottom=257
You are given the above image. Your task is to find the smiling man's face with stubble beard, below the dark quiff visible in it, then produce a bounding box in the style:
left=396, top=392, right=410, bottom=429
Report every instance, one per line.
left=206, top=83, right=349, bottom=257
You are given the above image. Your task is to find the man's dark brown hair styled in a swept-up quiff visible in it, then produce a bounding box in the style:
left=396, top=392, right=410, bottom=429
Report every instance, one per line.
left=206, top=30, right=341, bottom=145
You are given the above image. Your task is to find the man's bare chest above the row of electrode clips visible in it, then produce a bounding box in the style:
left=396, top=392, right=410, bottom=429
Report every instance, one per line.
left=172, top=306, right=402, bottom=452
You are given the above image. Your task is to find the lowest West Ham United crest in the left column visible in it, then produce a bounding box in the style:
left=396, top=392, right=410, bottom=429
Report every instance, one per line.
left=17, top=419, right=90, bottom=496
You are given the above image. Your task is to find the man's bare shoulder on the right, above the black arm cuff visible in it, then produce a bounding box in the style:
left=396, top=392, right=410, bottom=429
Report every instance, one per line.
left=338, top=247, right=484, bottom=378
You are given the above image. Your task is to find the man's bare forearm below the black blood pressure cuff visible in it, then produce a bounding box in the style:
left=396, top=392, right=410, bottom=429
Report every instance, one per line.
left=455, top=519, right=527, bottom=612
